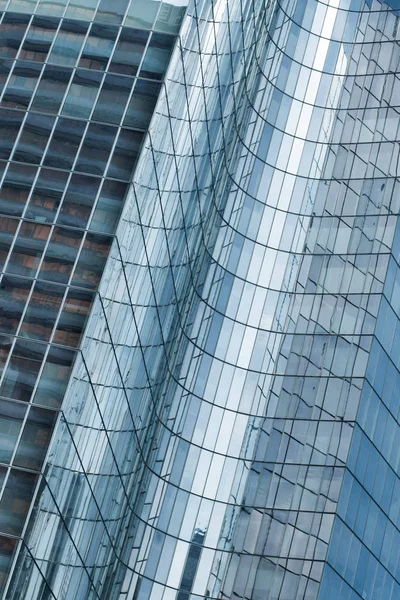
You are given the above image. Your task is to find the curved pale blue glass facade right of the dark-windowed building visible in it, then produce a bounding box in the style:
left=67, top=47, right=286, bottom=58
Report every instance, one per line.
left=4, top=0, right=400, bottom=600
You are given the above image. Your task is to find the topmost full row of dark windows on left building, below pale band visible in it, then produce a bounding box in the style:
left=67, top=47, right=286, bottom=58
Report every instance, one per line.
left=0, top=15, right=175, bottom=79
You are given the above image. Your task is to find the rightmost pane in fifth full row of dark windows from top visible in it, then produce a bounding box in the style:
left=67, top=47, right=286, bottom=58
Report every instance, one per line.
left=72, top=233, right=113, bottom=288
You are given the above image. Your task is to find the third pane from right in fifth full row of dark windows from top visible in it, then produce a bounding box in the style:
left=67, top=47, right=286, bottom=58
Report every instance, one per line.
left=7, top=222, right=50, bottom=277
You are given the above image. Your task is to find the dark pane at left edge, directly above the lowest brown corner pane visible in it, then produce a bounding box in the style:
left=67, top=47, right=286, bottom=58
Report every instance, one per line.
left=0, top=469, right=37, bottom=535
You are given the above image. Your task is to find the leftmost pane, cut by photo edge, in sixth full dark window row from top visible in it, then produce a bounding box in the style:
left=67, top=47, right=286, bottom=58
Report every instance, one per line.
left=0, top=276, right=32, bottom=334
